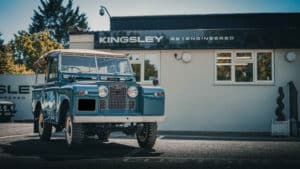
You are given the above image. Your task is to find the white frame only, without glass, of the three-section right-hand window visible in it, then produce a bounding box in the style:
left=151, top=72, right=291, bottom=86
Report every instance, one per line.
left=214, top=49, right=275, bottom=85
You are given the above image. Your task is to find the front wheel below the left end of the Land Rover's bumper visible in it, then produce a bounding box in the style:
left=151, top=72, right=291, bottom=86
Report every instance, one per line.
left=65, top=113, right=85, bottom=148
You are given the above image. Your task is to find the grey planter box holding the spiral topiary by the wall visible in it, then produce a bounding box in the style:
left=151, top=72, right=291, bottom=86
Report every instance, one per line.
left=271, top=120, right=290, bottom=136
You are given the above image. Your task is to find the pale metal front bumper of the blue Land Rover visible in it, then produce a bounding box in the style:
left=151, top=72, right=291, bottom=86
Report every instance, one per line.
left=73, top=115, right=166, bottom=123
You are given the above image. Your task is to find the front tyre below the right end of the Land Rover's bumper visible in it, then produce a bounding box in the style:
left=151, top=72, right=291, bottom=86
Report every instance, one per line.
left=136, top=123, right=157, bottom=149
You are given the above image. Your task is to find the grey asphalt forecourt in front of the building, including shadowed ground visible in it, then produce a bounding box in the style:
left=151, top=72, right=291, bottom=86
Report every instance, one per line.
left=0, top=123, right=300, bottom=169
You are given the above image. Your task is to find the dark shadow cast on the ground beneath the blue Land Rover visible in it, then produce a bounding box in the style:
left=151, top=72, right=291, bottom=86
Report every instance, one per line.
left=0, top=139, right=161, bottom=161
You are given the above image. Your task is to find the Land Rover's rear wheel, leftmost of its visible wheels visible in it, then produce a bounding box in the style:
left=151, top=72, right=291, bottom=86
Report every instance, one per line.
left=38, top=111, right=52, bottom=141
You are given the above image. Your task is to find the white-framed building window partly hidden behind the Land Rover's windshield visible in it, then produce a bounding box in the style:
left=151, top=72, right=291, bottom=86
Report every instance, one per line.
left=129, top=54, right=160, bottom=84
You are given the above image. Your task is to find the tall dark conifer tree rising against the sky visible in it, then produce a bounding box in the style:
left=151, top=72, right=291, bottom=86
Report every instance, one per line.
left=29, top=0, right=88, bottom=47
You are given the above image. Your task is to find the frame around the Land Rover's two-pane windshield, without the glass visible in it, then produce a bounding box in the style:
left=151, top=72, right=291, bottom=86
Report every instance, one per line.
left=58, top=53, right=134, bottom=76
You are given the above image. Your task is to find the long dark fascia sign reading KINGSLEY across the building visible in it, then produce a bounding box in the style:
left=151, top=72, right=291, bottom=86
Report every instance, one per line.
left=94, top=28, right=300, bottom=49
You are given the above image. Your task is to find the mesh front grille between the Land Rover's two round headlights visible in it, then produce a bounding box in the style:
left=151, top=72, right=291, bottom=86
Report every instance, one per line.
left=108, top=83, right=127, bottom=110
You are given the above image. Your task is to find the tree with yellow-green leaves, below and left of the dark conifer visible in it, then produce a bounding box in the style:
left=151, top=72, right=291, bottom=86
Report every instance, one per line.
left=11, top=29, right=63, bottom=70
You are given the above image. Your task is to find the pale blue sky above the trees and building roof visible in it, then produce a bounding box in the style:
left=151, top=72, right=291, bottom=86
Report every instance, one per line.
left=0, top=0, right=300, bottom=43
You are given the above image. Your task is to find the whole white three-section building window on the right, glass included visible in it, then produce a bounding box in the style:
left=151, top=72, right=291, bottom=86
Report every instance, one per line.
left=215, top=50, right=274, bottom=84
